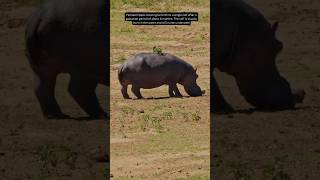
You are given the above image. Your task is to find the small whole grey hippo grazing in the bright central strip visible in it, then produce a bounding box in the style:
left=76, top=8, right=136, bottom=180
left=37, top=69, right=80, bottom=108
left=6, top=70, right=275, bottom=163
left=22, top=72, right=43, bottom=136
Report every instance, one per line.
left=118, top=53, right=204, bottom=99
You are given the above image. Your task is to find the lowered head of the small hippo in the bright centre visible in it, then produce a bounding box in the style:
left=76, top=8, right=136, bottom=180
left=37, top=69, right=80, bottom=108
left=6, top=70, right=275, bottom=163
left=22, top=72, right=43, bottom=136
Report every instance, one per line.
left=181, top=68, right=205, bottom=96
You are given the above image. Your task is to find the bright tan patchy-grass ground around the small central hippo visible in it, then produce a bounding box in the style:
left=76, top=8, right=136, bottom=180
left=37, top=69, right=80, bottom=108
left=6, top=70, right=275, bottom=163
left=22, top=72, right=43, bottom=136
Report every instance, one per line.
left=110, top=0, right=210, bottom=179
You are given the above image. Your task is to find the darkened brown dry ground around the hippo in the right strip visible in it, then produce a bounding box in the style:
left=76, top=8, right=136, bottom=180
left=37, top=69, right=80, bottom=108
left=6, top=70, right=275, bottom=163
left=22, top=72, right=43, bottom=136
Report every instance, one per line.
left=212, top=0, right=320, bottom=180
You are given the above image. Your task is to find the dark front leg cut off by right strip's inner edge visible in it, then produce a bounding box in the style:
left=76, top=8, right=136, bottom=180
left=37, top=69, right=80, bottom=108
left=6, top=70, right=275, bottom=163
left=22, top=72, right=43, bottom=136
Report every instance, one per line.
left=212, top=77, right=234, bottom=113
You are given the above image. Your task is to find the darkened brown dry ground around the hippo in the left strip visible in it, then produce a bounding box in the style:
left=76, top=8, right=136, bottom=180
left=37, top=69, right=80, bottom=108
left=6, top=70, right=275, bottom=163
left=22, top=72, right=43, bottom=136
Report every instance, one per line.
left=0, top=0, right=108, bottom=180
